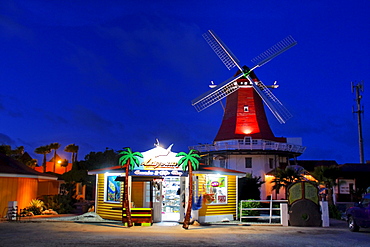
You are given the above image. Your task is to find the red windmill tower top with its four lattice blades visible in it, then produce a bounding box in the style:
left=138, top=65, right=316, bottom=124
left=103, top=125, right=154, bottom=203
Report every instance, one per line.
left=192, top=30, right=297, bottom=141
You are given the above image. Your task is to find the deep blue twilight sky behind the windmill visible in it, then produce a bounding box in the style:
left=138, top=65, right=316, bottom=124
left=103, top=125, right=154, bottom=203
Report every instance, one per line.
left=0, top=0, right=370, bottom=163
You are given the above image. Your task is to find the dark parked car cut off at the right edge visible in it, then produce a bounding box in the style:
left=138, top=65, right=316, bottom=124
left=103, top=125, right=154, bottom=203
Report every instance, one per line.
left=346, top=193, right=370, bottom=232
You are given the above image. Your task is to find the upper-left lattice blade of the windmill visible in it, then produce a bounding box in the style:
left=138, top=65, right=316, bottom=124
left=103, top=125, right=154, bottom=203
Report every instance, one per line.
left=203, top=30, right=242, bottom=71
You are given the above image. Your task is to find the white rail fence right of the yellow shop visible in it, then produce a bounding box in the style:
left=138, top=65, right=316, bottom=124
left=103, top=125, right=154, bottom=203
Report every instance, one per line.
left=239, top=200, right=288, bottom=225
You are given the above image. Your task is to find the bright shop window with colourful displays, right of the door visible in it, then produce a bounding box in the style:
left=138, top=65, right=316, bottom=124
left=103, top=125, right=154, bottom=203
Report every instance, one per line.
left=204, top=175, right=227, bottom=204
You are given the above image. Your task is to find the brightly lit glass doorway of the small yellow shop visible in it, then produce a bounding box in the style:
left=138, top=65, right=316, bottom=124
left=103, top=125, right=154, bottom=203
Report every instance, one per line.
left=162, top=177, right=181, bottom=222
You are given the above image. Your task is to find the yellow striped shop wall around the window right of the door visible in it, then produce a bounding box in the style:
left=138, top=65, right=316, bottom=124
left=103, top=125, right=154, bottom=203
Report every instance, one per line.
left=197, top=174, right=237, bottom=218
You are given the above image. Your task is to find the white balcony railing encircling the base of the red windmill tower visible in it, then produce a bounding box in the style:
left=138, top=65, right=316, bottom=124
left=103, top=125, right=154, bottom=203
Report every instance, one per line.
left=189, top=139, right=306, bottom=153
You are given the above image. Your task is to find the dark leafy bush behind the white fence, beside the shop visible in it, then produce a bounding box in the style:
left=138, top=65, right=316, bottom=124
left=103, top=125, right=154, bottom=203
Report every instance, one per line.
left=238, top=173, right=265, bottom=200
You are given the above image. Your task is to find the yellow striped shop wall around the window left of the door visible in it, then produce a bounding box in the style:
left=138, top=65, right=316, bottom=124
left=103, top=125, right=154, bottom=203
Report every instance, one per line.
left=96, top=174, right=123, bottom=221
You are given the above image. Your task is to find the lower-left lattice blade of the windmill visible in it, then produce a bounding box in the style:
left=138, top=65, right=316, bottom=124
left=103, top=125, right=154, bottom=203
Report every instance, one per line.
left=191, top=73, right=244, bottom=112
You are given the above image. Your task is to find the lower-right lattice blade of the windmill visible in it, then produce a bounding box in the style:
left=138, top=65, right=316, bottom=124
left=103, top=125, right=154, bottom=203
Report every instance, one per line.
left=247, top=75, right=293, bottom=124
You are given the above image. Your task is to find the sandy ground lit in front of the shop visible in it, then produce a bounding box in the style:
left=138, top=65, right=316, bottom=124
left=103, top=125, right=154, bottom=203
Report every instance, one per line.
left=0, top=216, right=370, bottom=247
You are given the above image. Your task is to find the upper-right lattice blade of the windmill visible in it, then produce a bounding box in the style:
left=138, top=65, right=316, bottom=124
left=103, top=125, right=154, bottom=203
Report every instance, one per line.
left=251, top=36, right=297, bottom=70
